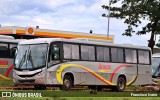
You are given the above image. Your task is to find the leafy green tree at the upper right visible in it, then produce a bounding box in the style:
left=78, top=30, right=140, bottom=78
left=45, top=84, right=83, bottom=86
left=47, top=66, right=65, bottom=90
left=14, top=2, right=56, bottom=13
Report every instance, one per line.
left=102, top=0, right=160, bottom=51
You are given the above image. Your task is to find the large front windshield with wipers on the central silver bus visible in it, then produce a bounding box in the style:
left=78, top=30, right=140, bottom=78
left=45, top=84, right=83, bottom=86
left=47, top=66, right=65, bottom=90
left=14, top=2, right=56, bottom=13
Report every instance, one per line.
left=15, top=44, right=47, bottom=70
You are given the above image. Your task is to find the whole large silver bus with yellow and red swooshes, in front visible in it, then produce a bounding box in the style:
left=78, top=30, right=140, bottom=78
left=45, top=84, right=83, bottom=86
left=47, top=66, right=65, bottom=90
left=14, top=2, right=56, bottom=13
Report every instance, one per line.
left=13, top=38, right=152, bottom=91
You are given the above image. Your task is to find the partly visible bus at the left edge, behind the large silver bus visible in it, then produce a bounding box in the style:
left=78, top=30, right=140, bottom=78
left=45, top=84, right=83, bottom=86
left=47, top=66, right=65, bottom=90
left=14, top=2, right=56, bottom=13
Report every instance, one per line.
left=0, top=35, right=20, bottom=80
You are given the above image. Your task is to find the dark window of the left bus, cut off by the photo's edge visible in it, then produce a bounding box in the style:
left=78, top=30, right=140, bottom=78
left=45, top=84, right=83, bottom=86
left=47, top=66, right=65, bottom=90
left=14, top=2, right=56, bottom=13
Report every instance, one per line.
left=0, top=43, right=9, bottom=58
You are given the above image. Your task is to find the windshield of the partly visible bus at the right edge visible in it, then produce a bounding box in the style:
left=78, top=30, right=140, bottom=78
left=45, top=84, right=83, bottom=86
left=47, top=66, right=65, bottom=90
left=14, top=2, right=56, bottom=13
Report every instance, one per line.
left=152, top=57, right=160, bottom=77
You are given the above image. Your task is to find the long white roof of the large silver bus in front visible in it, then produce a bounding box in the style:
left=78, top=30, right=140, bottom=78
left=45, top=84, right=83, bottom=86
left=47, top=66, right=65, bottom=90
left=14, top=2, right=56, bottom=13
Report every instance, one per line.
left=19, top=38, right=150, bottom=50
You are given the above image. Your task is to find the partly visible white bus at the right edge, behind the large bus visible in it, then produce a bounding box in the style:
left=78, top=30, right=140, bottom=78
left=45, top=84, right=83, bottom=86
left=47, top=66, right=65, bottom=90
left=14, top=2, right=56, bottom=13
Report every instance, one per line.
left=152, top=53, right=160, bottom=85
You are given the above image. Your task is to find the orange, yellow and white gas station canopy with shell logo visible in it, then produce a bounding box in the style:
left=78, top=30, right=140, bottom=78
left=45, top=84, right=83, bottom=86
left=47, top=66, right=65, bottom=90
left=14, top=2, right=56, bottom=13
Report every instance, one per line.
left=0, top=26, right=114, bottom=42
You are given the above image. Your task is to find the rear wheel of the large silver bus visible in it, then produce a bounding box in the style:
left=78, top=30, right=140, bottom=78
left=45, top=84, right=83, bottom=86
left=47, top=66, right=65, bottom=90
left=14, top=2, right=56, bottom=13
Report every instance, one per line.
left=116, top=77, right=126, bottom=92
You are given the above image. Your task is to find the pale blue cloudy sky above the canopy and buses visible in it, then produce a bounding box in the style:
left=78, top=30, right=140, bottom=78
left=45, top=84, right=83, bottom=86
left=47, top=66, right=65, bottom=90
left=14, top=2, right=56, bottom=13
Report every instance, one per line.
left=0, top=0, right=156, bottom=46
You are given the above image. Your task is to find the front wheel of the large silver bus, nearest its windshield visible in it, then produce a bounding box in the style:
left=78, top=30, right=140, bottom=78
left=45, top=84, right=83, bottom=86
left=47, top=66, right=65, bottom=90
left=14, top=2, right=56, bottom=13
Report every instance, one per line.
left=62, top=75, right=73, bottom=91
